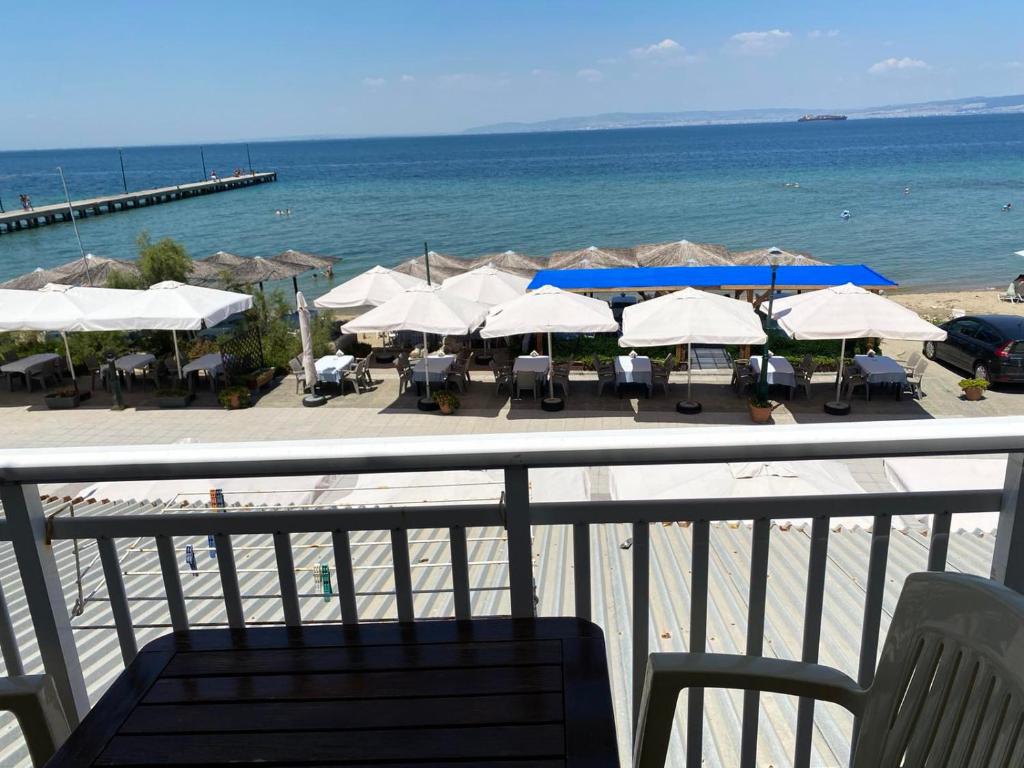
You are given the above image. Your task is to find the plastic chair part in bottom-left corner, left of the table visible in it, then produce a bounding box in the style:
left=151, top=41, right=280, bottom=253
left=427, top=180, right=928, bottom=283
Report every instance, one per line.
left=0, top=675, right=71, bottom=768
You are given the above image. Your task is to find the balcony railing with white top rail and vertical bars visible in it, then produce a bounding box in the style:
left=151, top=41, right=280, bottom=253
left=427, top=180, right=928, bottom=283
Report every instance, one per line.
left=0, top=417, right=1024, bottom=766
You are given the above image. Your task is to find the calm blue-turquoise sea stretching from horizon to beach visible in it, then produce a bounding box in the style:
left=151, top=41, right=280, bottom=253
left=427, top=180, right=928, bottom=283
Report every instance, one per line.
left=0, top=116, right=1024, bottom=295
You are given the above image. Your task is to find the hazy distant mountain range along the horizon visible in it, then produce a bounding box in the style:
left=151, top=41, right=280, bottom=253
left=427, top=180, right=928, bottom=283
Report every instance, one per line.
left=464, top=94, right=1024, bottom=133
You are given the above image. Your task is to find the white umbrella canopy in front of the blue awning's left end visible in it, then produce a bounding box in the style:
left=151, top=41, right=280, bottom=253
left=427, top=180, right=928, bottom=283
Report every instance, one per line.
left=480, top=286, right=618, bottom=339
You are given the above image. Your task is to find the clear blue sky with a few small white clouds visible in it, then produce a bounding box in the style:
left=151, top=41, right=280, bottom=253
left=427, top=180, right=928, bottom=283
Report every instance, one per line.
left=0, top=0, right=1024, bottom=151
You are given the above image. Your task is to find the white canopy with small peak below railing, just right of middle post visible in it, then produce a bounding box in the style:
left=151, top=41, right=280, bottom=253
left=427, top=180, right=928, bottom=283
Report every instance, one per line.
left=608, top=461, right=871, bottom=526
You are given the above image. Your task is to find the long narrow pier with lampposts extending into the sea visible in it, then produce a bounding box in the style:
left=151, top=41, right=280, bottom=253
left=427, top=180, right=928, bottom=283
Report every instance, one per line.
left=0, top=171, right=278, bottom=232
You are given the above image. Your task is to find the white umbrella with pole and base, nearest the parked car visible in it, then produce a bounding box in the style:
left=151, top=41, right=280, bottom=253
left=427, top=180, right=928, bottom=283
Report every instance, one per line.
left=761, top=283, right=946, bottom=410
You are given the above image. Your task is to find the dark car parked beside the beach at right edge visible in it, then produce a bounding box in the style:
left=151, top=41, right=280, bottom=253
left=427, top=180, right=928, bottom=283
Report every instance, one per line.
left=924, top=314, right=1024, bottom=383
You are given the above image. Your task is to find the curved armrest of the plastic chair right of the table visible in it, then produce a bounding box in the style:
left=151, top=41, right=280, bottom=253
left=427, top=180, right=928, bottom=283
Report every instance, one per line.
left=633, top=653, right=866, bottom=768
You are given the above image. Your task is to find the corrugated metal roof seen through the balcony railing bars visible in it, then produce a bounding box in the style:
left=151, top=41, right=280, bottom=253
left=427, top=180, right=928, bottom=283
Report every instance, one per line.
left=0, top=487, right=993, bottom=767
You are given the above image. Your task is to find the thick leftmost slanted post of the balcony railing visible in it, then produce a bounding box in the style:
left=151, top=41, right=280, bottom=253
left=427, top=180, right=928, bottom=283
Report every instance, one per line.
left=0, top=483, right=89, bottom=726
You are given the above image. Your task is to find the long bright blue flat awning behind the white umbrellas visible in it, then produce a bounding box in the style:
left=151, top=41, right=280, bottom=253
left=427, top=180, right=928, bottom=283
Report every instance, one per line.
left=529, top=264, right=896, bottom=292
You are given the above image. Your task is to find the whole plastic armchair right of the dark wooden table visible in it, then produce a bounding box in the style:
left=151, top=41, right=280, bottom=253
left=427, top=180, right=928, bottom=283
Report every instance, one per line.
left=633, top=572, right=1024, bottom=768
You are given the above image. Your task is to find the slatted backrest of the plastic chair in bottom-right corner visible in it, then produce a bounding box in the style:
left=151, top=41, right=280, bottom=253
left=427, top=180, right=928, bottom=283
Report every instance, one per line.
left=853, top=573, right=1024, bottom=768
